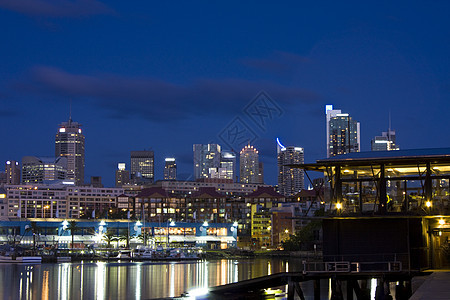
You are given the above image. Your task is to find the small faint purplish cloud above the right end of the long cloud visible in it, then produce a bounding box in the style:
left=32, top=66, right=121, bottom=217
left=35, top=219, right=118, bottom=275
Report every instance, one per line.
left=242, top=51, right=311, bottom=76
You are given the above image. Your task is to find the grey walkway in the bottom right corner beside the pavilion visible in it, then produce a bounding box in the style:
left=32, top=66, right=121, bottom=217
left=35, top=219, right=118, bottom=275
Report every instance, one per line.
left=409, top=270, right=450, bottom=300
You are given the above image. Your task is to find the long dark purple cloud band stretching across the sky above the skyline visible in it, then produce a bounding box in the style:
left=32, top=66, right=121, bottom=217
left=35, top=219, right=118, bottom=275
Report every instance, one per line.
left=18, top=66, right=321, bottom=122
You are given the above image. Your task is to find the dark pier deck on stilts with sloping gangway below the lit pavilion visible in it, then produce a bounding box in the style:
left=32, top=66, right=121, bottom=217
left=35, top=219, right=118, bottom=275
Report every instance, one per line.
left=209, top=262, right=420, bottom=300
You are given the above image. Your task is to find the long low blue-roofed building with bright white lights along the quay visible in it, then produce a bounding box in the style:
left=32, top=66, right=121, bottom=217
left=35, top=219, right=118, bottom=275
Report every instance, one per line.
left=0, top=217, right=237, bottom=249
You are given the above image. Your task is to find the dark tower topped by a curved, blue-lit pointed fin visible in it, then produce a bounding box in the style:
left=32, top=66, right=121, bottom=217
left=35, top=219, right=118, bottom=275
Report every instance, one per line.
left=277, top=139, right=305, bottom=197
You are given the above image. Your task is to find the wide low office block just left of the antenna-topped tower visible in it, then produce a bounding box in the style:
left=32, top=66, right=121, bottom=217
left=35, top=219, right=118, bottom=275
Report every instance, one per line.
left=22, top=156, right=69, bottom=184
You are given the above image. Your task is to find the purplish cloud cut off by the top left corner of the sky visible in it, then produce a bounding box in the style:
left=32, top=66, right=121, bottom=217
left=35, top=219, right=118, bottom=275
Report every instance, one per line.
left=0, top=0, right=113, bottom=17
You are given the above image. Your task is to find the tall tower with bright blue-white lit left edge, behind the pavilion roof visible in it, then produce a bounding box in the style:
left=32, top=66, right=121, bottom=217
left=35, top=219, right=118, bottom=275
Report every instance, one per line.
left=325, top=105, right=361, bottom=157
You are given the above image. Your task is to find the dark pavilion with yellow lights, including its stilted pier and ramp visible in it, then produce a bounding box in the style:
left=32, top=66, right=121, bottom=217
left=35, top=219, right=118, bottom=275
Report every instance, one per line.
left=208, top=148, right=450, bottom=300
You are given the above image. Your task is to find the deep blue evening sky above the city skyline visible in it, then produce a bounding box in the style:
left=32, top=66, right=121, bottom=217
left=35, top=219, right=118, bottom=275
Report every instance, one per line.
left=0, top=0, right=450, bottom=185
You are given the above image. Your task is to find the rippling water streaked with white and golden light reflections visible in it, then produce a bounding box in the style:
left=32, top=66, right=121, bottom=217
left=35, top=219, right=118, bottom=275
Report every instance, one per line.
left=0, top=259, right=350, bottom=300
